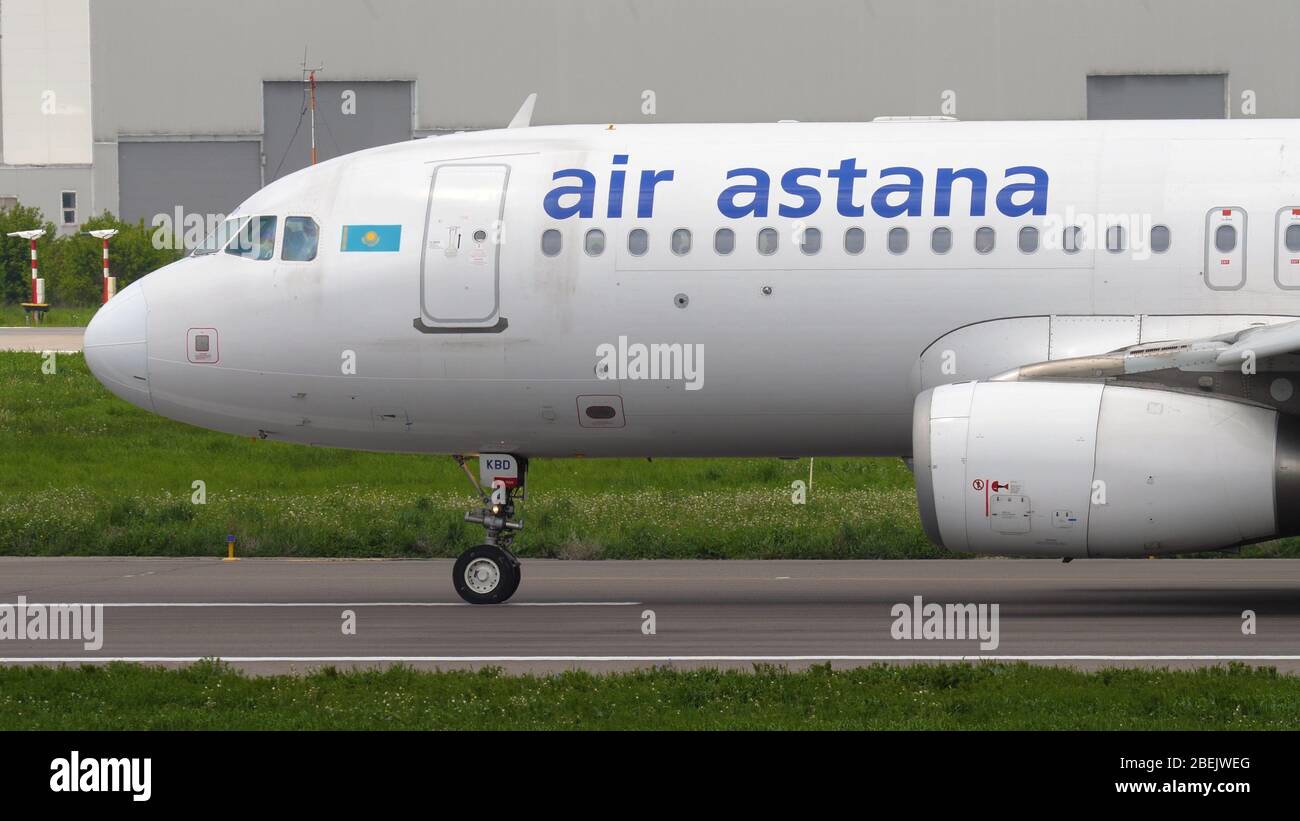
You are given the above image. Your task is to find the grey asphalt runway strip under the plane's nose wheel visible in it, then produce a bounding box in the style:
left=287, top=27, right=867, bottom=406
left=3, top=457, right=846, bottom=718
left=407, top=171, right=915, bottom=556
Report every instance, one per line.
left=0, top=559, right=1300, bottom=673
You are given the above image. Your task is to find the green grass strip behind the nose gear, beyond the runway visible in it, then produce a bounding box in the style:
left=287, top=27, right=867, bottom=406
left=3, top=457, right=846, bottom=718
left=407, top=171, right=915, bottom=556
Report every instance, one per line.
left=0, top=353, right=1300, bottom=559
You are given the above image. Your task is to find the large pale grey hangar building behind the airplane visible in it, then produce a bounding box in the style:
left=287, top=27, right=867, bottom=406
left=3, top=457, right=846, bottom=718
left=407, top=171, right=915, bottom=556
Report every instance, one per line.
left=0, top=0, right=1300, bottom=237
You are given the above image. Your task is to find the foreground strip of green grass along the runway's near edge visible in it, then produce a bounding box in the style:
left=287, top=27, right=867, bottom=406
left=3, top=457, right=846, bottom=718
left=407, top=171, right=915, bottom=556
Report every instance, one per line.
left=0, top=663, right=1300, bottom=730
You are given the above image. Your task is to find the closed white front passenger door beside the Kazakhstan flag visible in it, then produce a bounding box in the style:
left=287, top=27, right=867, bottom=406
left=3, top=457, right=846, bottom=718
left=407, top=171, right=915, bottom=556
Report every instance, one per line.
left=416, top=164, right=510, bottom=333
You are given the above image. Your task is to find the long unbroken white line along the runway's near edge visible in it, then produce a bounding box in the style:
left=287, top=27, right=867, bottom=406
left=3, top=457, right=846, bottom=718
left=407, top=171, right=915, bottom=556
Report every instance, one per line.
left=0, top=655, right=1300, bottom=664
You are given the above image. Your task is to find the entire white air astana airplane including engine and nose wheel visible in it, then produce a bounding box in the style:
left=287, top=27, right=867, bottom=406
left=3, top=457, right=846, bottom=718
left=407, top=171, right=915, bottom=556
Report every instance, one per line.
left=85, top=97, right=1300, bottom=604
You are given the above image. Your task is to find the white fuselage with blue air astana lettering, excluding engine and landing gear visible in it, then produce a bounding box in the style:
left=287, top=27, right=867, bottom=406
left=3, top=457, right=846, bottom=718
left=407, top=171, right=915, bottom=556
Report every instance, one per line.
left=87, top=121, right=1300, bottom=457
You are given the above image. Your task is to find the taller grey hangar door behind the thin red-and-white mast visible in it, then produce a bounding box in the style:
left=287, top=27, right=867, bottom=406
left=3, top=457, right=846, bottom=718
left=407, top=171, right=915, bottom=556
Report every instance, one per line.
left=261, top=81, right=413, bottom=184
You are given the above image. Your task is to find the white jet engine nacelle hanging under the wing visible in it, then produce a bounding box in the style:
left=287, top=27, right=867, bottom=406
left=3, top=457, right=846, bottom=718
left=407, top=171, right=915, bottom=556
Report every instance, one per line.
left=913, top=382, right=1300, bottom=557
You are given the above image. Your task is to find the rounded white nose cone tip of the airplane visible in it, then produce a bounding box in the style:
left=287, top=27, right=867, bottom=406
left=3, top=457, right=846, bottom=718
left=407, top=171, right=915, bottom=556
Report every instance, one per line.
left=83, top=282, right=153, bottom=411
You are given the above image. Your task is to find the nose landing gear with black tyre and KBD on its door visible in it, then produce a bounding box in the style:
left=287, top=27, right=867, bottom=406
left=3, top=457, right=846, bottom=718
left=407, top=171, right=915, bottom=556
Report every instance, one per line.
left=451, top=456, right=528, bottom=604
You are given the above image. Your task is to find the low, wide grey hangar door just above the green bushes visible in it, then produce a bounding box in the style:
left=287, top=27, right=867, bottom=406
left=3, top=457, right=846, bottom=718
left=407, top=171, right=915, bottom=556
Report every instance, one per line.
left=117, top=140, right=261, bottom=225
